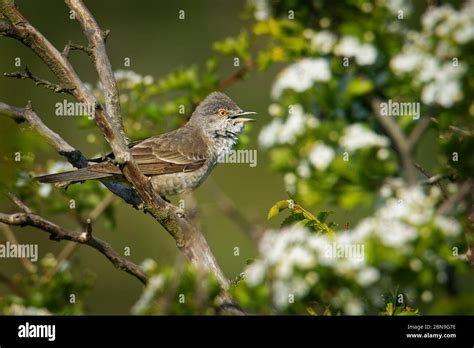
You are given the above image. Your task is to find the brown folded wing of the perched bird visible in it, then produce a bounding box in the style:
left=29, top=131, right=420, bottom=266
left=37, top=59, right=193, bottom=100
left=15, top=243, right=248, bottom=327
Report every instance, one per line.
left=90, top=128, right=206, bottom=175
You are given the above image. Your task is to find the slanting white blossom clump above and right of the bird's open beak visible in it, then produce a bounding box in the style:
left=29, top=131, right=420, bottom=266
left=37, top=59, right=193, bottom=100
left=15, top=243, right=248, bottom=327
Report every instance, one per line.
left=271, top=58, right=331, bottom=99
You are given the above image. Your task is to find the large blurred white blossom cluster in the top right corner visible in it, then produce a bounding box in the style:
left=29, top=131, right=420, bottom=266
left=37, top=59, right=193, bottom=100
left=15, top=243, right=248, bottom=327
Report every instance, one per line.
left=390, top=0, right=474, bottom=107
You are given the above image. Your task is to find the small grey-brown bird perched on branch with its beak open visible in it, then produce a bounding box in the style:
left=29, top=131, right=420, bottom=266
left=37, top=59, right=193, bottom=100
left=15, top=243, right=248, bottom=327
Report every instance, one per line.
left=36, top=92, right=255, bottom=197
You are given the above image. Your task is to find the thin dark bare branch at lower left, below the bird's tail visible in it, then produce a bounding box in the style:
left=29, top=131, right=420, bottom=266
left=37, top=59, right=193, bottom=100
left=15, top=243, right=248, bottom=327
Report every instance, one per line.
left=0, top=194, right=148, bottom=284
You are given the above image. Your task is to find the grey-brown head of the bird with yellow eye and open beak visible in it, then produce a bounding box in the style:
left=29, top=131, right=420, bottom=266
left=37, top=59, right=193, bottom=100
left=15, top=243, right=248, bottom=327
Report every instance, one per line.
left=189, top=92, right=255, bottom=135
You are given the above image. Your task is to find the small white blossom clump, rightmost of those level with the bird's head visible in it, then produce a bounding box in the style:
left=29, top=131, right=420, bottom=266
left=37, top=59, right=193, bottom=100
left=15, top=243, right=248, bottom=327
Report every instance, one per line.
left=339, top=123, right=389, bottom=152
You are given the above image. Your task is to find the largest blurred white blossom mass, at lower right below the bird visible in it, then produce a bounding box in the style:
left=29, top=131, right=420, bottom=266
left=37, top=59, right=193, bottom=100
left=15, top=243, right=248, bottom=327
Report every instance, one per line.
left=245, top=184, right=461, bottom=314
